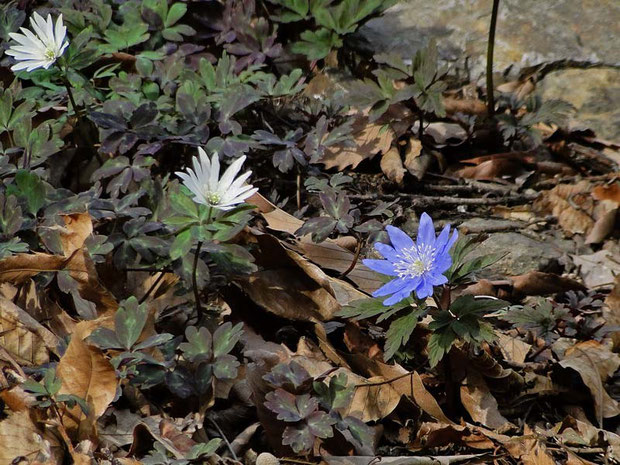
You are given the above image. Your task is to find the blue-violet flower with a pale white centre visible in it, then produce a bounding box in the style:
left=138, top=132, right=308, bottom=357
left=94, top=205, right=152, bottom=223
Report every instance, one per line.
left=363, top=213, right=458, bottom=306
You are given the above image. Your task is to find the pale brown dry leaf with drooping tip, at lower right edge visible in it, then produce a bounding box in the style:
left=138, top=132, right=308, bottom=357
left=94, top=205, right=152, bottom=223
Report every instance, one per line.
left=560, top=341, right=620, bottom=425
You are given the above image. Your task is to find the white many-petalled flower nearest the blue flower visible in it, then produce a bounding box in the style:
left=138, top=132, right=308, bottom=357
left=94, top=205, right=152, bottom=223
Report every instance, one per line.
left=175, top=148, right=258, bottom=210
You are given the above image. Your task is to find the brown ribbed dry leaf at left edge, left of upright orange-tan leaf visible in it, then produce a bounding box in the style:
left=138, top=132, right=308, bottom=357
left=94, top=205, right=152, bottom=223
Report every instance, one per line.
left=0, top=297, right=59, bottom=366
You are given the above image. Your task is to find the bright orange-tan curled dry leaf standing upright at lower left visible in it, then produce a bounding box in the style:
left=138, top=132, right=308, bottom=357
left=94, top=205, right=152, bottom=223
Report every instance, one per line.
left=56, top=317, right=118, bottom=439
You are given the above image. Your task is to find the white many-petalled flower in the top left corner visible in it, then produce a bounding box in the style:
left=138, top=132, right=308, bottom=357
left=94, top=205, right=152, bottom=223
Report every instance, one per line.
left=6, top=11, right=69, bottom=72
